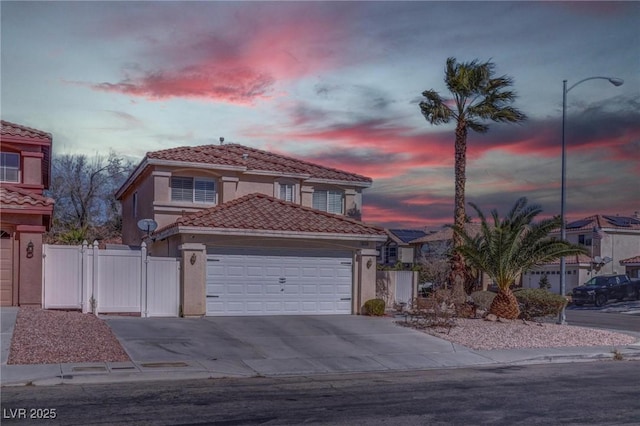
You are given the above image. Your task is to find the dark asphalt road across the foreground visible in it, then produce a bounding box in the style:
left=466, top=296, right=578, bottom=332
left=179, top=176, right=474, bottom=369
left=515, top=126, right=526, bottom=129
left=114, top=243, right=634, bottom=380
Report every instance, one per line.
left=2, top=361, right=640, bottom=426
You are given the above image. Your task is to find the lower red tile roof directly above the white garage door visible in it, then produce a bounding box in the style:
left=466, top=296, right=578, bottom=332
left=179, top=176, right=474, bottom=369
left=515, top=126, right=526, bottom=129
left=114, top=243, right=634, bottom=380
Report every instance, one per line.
left=155, top=194, right=386, bottom=236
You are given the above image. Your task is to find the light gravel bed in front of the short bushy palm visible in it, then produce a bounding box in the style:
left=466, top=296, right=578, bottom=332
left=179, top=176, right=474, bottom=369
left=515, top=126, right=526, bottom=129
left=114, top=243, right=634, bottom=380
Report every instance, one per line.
left=408, top=319, right=638, bottom=350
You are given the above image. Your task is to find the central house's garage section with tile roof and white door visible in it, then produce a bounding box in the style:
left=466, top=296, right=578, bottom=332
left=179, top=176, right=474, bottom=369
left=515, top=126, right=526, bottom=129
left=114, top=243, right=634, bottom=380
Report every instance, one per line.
left=150, top=194, right=386, bottom=316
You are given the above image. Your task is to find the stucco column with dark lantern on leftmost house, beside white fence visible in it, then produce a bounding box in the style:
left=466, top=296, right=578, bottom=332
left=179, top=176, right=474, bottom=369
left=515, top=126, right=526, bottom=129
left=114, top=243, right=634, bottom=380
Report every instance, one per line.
left=14, top=230, right=44, bottom=306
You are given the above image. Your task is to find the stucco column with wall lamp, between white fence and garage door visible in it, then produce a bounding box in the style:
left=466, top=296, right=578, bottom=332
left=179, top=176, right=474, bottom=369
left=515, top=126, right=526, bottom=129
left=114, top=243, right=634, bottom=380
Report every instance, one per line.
left=178, top=243, right=207, bottom=317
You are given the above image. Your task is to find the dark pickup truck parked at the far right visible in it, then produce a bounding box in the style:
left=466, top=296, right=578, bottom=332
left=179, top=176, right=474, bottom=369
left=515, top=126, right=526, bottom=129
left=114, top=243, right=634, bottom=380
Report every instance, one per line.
left=571, top=275, right=640, bottom=307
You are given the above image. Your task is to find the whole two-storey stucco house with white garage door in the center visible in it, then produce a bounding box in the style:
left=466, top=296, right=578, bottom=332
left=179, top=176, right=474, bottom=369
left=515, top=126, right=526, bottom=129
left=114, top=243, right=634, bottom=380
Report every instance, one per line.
left=116, top=144, right=386, bottom=316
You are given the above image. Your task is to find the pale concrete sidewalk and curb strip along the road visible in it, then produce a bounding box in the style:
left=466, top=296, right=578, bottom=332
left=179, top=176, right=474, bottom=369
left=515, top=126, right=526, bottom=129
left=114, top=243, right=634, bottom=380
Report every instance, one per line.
left=1, top=342, right=640, bottom=387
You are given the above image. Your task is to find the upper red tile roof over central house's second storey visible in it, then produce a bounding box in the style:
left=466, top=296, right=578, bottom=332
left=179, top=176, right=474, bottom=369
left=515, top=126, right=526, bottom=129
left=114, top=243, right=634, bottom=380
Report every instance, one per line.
left=147, top=144, right=371, bottom=183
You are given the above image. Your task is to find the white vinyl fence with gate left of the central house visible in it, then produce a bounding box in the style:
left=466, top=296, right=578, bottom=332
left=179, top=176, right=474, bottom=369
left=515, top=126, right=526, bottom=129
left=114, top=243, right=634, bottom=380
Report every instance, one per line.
left=43, top=242, right=180, bottom=317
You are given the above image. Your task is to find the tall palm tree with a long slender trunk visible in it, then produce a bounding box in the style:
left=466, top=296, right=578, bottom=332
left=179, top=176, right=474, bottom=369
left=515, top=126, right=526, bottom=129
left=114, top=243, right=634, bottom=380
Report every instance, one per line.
left=420, top=58, right=526, bottom=303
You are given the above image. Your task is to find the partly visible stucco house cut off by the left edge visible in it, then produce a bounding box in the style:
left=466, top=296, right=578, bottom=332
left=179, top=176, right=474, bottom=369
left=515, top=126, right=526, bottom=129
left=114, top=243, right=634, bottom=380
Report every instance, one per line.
left=0, top=120, right=53, bottom=306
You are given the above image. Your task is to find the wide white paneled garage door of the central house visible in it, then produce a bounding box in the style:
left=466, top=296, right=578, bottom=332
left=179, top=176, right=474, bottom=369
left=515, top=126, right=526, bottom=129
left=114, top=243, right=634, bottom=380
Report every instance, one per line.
left=207, top=249, right=352, bottom=316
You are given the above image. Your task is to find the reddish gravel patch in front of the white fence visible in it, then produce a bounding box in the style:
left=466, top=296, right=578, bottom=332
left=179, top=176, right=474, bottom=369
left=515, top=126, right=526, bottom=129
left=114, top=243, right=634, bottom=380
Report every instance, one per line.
left=7, top=307, right=129, bottom=364
